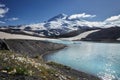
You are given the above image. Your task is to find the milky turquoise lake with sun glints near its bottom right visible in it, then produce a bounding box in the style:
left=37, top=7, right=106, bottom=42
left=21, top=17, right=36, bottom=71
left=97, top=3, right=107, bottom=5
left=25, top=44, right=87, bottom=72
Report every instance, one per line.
left=45, top=41, right=120, bottom=80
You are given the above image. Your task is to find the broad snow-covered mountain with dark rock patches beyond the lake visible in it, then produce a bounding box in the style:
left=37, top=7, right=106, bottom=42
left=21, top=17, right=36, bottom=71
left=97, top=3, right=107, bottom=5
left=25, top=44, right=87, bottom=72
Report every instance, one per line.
left=21, top=14, right=100, bottom=36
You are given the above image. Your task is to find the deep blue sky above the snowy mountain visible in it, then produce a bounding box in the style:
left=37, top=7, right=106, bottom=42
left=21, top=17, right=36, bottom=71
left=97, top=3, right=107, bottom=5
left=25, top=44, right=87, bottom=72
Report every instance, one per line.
left=0, top=0, right=120, bottom=25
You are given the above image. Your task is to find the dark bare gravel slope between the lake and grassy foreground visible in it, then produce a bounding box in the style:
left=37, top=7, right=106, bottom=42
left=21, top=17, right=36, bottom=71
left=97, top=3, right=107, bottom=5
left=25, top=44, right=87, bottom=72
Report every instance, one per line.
left=4, top=39, right=65, bottom=57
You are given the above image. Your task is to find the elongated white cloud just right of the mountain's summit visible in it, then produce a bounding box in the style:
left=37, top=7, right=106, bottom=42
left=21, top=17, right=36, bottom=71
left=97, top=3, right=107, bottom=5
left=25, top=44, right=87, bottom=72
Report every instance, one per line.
left=68, top=13, right=96, bottom=19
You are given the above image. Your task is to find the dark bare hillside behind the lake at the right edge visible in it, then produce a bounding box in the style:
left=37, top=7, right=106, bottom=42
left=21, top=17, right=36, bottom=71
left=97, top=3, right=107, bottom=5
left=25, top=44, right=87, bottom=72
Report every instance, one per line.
left=83, top=27, right=120, bottom=40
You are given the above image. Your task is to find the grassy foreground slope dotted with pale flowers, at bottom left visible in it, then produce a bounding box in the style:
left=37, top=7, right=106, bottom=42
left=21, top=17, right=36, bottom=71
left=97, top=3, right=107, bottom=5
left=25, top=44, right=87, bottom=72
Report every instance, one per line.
left=0, top=50, right=77, bottom=80
